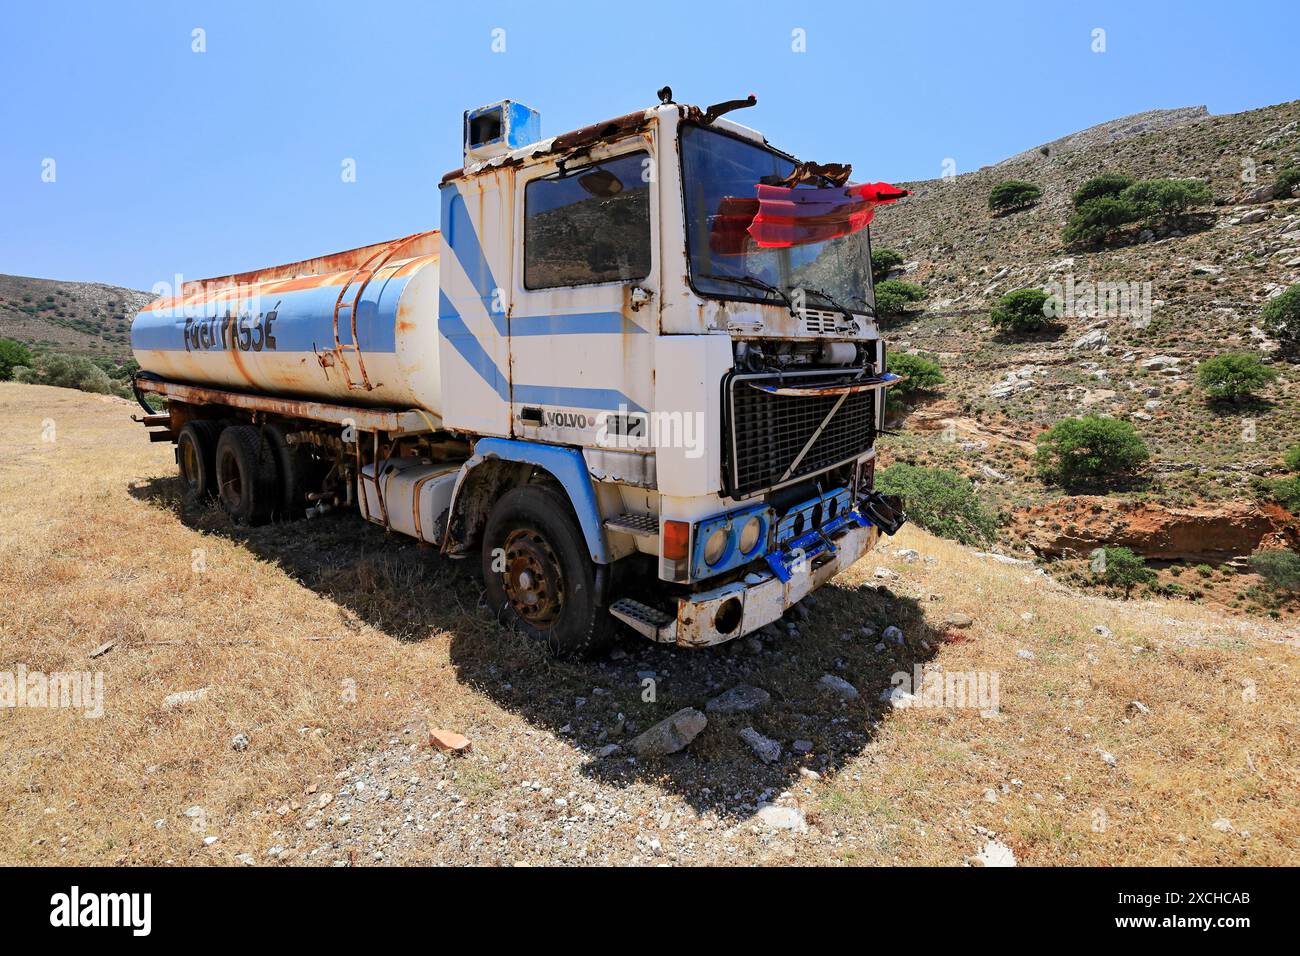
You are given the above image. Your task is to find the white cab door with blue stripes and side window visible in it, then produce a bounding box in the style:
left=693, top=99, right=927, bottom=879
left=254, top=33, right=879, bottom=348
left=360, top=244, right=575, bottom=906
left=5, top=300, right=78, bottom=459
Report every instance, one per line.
left=510, top=133, right=659, bottom=446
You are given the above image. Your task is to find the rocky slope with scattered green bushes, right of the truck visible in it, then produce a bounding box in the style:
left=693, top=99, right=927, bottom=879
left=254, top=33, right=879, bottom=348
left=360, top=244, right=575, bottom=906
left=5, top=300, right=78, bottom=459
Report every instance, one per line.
left=874, top=101, right=1300, bottom=590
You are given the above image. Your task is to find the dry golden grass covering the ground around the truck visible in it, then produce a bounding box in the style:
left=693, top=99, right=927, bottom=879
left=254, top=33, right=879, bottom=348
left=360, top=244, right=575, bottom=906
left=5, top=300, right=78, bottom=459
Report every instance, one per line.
left=0, top=384, right=1300, bottom=865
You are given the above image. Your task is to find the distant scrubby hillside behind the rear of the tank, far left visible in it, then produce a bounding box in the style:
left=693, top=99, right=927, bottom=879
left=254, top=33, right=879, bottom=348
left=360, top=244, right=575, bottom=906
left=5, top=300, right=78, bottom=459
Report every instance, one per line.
left=0, top=276, right=155, bottom=362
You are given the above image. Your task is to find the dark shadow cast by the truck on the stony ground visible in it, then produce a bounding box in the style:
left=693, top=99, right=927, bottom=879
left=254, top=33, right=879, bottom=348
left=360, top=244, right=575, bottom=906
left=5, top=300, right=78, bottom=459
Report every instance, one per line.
left=130, top=479, right=945, bottom=818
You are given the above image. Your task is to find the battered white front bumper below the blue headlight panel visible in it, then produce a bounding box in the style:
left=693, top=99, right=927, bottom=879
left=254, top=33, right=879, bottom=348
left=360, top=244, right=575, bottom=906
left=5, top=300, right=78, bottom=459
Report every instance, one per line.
left=611, top=515, right=880, bottom=648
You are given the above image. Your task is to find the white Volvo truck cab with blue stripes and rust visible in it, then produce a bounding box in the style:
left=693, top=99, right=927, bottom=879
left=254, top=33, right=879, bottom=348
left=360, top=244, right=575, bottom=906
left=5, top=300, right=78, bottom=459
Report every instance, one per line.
left=438, top=100, right=902, bottom=645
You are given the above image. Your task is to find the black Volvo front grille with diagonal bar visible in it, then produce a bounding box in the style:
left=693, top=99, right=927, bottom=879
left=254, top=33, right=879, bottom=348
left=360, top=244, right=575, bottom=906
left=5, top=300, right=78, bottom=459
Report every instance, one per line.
left=724, top=373, right=876, bottom=498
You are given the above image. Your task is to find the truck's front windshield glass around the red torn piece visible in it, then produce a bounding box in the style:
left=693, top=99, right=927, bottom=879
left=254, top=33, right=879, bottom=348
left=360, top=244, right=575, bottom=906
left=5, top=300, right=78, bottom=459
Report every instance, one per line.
left=681, top=126, right=871, bottom=312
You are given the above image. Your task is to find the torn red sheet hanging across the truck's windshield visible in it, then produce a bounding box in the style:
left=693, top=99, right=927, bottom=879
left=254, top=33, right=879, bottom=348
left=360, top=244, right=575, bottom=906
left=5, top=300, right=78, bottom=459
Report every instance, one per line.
left=709, top=182, right=909, bottom=255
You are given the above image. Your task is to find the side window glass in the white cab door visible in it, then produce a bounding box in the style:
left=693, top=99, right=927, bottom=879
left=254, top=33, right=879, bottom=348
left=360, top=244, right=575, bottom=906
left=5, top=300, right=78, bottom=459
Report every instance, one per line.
left=524, top=152, right=650, bottom=289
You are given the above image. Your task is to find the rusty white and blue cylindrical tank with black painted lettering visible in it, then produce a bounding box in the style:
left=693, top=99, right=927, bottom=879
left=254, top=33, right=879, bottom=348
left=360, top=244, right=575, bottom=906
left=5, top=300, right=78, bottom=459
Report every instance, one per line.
left=131, top=243, right=442, bottom=415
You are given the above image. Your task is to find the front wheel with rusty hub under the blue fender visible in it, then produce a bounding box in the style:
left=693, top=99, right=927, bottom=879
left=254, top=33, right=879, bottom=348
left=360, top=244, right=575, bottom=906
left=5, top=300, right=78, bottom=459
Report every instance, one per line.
left=482, top=485, right=614, bottom=657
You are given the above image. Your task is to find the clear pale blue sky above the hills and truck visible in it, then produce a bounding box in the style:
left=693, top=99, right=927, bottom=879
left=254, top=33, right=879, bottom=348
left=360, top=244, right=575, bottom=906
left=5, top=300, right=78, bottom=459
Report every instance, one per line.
left=0, top=0, right=1300, bottom=289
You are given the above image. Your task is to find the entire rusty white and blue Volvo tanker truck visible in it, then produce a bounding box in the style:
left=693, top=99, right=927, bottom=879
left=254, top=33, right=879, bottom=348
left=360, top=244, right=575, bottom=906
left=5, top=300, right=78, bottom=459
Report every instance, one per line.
left=131, top=88, right=906, bottom=654
